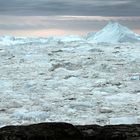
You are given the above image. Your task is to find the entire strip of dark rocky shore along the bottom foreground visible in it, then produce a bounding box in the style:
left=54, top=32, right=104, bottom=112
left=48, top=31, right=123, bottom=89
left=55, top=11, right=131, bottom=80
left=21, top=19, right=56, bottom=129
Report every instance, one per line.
left=0, top=123, right=140, bottom=140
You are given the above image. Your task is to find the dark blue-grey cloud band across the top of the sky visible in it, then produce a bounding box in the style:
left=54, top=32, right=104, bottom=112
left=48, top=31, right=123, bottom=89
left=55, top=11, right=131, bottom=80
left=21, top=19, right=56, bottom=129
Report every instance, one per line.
left=0, top=0, right=140, bottom=16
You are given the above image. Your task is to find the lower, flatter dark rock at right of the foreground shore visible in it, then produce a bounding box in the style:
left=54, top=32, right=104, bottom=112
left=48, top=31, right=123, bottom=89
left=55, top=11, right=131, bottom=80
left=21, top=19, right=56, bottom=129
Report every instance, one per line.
left=76, top=124, right=140, bottom=140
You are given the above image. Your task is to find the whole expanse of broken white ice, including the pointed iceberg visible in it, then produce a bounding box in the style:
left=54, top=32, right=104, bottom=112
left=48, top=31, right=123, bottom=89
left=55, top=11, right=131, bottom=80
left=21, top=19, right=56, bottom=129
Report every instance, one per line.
left=0, top=23, right=140, bottom=126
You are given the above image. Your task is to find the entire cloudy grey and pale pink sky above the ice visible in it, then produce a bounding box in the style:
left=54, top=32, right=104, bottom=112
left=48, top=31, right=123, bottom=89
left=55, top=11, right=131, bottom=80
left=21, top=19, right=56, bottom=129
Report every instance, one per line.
left=0, top=0, right=140, bottom=37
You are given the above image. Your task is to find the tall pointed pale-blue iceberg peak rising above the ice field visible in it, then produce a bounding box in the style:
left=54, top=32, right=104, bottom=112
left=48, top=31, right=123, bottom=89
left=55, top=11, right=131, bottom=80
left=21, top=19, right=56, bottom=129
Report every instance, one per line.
left=88, top=21, right=140, bottom=43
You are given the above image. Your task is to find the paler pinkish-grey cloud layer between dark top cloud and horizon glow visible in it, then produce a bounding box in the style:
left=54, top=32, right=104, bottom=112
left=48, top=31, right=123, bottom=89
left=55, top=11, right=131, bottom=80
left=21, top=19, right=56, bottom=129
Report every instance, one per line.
left=0, top=17, right=140, bottom=32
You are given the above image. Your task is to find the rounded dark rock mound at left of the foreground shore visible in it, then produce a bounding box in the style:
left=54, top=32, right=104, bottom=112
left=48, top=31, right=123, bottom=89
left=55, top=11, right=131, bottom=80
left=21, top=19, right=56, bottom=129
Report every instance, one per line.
left=0, top=123, right=82, bottom=140
